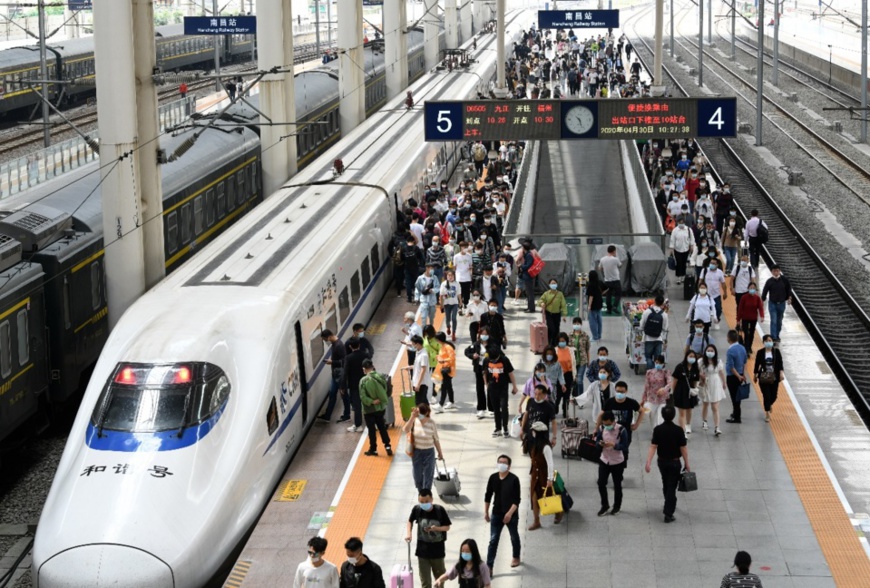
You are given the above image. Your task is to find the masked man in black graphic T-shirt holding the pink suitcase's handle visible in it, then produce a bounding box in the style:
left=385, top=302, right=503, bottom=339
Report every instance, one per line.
left=405, top=488, right=453, bottom=588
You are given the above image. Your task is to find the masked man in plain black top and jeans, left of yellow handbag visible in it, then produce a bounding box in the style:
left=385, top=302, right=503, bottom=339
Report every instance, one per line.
left=483, top=454, right=524, bottom=575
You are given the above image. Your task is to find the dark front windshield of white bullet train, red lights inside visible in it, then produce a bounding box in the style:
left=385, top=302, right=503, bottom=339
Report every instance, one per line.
left=91, top=362, right=230, bottom=434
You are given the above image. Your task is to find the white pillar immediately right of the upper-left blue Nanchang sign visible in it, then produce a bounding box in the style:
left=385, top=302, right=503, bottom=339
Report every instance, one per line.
left=257, top=0, right=296, bottom=197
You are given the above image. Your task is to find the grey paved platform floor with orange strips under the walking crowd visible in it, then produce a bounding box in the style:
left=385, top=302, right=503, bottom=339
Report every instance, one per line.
left=226, top=260, right=870, bottom=588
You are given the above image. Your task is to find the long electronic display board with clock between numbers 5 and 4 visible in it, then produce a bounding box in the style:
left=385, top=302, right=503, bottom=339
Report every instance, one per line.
left=424, top=98, right=737, bottom=141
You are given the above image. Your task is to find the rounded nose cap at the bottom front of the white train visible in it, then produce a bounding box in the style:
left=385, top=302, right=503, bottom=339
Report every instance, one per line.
left=37, top=544, right=175, bottom=588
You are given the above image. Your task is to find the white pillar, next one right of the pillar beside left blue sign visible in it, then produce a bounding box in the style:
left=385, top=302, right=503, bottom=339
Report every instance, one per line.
left=337, top=0, right=366, bottom=136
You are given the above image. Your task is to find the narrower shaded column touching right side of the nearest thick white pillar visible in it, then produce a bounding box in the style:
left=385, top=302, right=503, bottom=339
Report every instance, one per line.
left=133, top=0, right=166, bottom=288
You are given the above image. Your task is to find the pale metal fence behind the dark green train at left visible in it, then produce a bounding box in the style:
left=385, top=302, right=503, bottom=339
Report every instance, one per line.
left=0, top=96, right=196, bottom=200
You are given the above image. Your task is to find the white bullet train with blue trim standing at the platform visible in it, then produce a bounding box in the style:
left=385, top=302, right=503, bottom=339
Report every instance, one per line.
left=32, top=11, right=533, bottom=588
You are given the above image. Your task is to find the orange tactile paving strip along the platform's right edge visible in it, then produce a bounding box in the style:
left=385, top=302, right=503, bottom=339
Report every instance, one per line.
left=723, top=298, right=870, bottom=588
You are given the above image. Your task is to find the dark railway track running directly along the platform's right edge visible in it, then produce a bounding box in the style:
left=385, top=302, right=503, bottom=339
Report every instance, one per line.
left=635, top=28, right=870, bottom=426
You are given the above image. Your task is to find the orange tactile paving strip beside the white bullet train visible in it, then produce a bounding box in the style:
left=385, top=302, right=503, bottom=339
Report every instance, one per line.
left=325, top=311, right=444, bottom=561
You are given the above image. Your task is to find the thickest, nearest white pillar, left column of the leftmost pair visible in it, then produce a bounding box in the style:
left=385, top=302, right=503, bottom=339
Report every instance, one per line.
left=94, top=0, right=146, bottom=328
